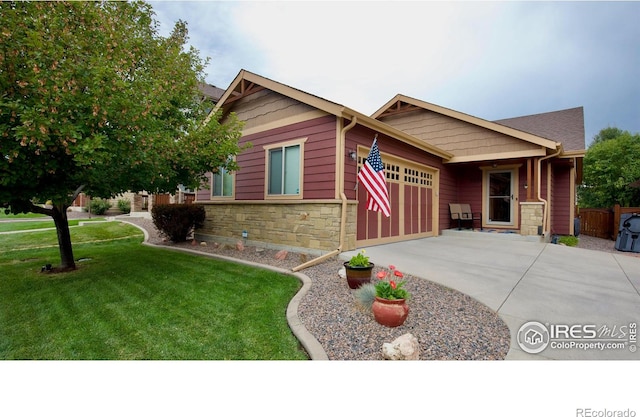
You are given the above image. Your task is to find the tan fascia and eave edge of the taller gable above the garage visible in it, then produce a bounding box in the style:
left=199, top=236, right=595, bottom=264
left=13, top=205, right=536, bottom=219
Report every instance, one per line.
left=214, top=69, right=453, bottom=160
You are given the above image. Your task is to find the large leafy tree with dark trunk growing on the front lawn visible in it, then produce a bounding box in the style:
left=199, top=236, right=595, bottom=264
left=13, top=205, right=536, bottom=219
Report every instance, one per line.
left=0, top=2, right=241, bottom=269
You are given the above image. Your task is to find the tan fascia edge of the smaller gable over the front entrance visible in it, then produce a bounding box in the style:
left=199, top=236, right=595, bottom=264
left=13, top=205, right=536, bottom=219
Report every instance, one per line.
left=371, top=94, right=560, bottom=150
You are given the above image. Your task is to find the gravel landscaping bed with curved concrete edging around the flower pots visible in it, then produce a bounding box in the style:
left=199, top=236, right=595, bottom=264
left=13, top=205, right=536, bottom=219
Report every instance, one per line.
left=123, top=217, right=510, bottom=360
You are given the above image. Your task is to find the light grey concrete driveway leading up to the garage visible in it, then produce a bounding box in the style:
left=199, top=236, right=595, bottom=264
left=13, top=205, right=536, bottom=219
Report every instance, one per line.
left=341, top=235, right=640, bottom=359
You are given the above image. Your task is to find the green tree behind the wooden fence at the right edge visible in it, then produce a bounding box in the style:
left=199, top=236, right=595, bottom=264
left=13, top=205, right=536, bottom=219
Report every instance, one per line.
left=579, top=128, right=640, bottom=208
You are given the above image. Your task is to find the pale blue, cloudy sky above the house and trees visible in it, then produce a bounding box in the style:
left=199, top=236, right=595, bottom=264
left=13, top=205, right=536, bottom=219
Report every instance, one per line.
left=149, top=1, right=640, bottom=146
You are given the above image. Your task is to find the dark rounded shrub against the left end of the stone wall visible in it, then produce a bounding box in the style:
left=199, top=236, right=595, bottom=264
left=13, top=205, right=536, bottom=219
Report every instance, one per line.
left=151, top=204, right=205, bottom=242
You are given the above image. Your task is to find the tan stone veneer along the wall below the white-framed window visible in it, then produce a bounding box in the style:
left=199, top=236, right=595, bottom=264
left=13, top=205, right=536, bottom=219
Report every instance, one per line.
left=195, top=200, right=357, bottom=254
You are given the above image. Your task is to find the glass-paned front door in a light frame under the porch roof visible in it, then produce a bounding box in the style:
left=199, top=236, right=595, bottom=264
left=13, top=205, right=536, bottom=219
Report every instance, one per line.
left=484, top=170, right=517, bottom=226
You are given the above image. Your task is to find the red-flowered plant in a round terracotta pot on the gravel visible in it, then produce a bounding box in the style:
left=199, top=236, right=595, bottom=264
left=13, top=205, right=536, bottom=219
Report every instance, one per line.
left=355, top=265, right=411, bottom=327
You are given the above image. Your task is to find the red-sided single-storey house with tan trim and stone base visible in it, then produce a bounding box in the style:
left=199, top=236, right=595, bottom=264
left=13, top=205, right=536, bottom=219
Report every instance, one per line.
left=195, top=70, right=584, bottom=253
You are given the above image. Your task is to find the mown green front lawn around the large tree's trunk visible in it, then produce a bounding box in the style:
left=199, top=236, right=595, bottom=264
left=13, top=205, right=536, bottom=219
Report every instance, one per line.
left=0, top=222, right=307, bottom=360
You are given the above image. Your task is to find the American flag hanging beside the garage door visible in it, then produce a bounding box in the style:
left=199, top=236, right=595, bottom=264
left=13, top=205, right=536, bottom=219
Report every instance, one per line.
left=358, top=138, right=391, bottom=217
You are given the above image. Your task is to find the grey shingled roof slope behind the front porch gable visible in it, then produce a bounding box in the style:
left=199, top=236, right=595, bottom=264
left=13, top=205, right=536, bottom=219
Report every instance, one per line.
left=495, top=107, right=585, bottom=151
